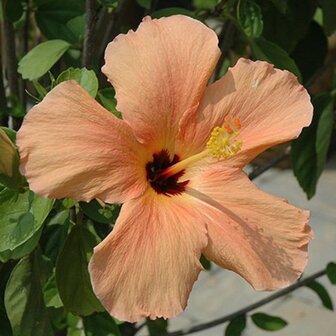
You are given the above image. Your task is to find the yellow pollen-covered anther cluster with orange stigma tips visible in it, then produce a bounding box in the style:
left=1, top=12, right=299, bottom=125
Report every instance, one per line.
left=207, top=116, right=242, bottom=159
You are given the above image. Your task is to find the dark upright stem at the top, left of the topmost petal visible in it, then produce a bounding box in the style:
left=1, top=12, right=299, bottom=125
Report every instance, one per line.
left=82, top=0, right=97, bottom=68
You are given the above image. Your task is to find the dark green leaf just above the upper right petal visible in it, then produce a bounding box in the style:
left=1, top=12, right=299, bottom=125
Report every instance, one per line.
left=251, top=37, right=301, bottom=81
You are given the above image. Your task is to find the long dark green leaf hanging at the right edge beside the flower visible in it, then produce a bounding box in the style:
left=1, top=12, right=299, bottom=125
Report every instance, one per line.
left=291, top=93, right=334, bottom=199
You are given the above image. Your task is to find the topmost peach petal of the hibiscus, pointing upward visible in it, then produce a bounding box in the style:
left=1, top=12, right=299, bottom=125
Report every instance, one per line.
left=102, top=15, right=220, bottom=153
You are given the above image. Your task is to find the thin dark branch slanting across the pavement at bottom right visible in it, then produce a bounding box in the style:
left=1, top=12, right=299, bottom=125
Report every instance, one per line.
left=162, top=269, right=326, bottom=336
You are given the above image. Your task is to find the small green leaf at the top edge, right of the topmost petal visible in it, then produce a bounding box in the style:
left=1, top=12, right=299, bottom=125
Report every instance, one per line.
left=237, top=0, right=264, bottom=37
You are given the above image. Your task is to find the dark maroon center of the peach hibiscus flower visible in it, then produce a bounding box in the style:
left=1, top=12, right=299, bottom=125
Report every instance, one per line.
left=146, top=150, right=189, bottom=196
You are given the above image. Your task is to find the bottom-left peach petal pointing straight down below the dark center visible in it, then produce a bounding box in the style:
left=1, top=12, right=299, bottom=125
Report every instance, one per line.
left=89, top=191, right=207, bottom=322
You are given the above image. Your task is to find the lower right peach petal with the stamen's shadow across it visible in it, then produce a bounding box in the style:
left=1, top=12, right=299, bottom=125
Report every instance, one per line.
left=187, top=169, right=312, bottom=290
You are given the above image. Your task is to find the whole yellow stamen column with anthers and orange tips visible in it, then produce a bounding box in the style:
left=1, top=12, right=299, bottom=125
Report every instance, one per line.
left=159, top=115, right=242, bottom=177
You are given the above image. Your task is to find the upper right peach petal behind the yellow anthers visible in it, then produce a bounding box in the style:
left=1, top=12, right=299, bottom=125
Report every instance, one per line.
left=176, top=59, right=313, bottom=166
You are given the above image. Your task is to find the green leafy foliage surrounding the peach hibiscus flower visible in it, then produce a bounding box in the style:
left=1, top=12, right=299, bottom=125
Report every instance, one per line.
left=0, top=0, right=336, bottom=336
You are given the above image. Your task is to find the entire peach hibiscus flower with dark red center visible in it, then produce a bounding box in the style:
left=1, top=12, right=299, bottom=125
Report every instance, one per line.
left=17, top=15, right=312, bottom=322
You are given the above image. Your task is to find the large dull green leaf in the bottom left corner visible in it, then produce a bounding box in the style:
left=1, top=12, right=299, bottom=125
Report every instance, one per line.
left=5, top=255, right=54, bottom=336
